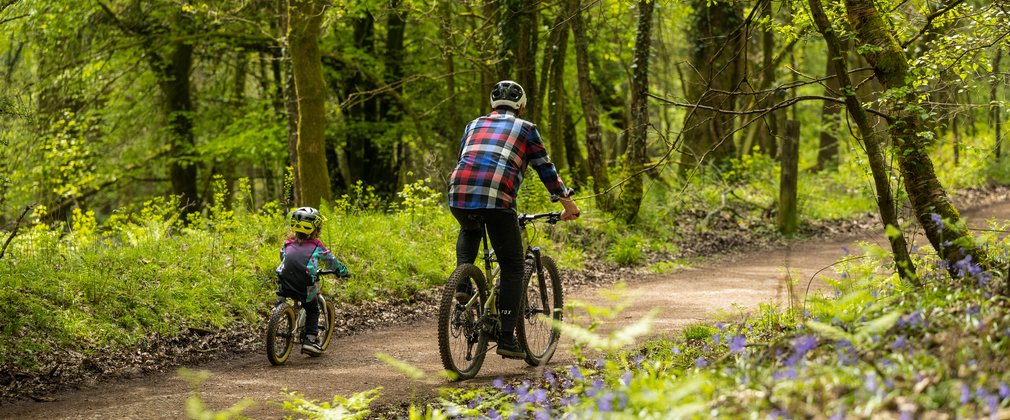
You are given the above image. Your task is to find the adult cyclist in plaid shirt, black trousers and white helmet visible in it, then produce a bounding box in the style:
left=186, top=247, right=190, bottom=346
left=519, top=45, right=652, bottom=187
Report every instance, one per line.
left=448, top=80, right=580, bottom=358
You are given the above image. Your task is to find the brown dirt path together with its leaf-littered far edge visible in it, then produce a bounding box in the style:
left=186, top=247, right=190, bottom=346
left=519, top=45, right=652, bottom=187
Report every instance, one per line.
left=0, top=187, right=1010, bottom=419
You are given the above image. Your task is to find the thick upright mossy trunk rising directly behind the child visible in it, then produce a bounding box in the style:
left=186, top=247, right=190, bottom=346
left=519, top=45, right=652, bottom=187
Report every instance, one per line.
left=288, top=0, right=331, bottom=207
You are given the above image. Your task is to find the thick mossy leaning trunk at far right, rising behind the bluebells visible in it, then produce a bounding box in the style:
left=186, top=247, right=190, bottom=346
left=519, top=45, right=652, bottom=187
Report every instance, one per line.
left=845, top=0, right=991, bottom=274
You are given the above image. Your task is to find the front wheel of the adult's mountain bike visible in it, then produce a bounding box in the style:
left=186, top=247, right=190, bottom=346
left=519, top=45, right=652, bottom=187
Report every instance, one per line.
left=516, top=255, right=565, bottom=366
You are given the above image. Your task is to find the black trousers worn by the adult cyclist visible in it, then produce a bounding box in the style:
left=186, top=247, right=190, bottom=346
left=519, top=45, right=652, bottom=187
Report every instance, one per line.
left=449, top=208, right=525, bottom=327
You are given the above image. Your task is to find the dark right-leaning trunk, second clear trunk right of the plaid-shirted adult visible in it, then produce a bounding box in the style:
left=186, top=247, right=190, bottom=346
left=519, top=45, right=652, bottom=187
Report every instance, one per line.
left=617, top=0, right=654, bottom=223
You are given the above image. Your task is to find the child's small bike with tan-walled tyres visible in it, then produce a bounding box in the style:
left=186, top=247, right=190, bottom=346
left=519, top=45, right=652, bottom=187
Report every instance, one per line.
left=267, top=270, right=346, bottom=365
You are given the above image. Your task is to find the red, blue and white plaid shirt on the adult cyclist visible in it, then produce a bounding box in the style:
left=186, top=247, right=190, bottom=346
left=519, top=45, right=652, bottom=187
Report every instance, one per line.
left=448, top=110, right=569, bottom=210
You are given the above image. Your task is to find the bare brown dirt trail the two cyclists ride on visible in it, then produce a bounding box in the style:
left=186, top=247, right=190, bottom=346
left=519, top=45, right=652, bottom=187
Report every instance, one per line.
left=0, top=200, right=1010, bottom=419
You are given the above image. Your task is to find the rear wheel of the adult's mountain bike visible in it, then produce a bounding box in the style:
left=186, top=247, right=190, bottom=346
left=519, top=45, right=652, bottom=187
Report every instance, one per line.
left=438, top=264, right=488, bottom=381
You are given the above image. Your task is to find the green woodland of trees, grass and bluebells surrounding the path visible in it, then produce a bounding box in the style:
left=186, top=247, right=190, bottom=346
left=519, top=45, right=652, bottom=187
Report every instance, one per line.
left=0, top=0, right=1010, bottom=416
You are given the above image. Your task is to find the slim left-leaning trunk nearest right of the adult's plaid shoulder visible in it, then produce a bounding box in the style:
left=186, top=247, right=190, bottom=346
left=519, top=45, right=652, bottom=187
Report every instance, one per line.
left=568, top=0, right=613, bottom=211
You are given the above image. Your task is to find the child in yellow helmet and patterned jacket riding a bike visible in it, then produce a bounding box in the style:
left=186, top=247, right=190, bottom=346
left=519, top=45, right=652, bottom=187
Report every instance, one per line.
left=277, top=207, right=348, bottom=355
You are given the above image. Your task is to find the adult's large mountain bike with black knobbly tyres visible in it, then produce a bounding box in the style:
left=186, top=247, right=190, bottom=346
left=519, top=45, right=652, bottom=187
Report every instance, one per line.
left=438, top=212, right=565, bottom=380
